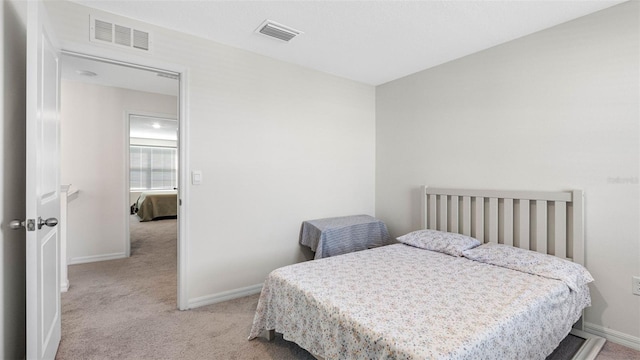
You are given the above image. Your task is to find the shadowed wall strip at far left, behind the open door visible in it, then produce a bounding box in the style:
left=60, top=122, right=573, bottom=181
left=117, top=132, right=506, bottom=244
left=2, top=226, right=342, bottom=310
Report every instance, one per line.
left=0, top=0, right=27, bottom=359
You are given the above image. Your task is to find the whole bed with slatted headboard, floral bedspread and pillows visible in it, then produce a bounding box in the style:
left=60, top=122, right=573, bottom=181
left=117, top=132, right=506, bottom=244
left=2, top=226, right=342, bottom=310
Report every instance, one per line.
left=249, top=186, right=602, bottom=359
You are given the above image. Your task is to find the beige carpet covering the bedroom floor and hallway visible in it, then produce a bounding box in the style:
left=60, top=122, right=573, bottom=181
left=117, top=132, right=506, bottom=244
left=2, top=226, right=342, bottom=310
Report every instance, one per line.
left=56, top=217, right=640, bottom=360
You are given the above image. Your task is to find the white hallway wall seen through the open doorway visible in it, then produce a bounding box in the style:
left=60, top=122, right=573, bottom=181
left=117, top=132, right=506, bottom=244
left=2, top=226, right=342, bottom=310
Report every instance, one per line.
left=61, top=81, right=178, bottom=264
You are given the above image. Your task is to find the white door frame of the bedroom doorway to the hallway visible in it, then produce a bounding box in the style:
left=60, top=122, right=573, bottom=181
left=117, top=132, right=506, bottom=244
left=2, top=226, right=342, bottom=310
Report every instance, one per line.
left=61, top=49, right=189, bottom=310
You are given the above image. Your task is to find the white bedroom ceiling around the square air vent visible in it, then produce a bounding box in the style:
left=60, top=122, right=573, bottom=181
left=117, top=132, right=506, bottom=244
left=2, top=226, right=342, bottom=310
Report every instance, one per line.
left=70, top=0, right=624, bottom=85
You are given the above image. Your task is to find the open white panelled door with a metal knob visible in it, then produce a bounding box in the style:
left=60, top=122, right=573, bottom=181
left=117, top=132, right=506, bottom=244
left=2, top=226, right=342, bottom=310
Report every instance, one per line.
left=25, top=1, right=61, bottom=359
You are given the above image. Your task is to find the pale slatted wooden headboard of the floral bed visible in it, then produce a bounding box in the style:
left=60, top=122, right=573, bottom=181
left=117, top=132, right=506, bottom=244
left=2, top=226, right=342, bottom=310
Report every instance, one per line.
left=422, top=186, right=584, bottom=265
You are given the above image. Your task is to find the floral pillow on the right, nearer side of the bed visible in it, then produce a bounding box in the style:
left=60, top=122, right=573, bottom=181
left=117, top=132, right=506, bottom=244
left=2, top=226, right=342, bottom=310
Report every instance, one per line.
left=463, top=243, right=593, bottom=291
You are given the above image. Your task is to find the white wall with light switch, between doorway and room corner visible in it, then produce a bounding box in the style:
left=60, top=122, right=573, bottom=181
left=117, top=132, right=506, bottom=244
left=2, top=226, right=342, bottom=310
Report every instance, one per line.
left=47, top=2, right=375, bottom=304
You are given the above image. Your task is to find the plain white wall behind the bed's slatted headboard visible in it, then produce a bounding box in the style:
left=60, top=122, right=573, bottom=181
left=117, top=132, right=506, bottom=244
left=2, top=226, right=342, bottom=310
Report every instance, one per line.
left=376, top=1, right=640, bottom=347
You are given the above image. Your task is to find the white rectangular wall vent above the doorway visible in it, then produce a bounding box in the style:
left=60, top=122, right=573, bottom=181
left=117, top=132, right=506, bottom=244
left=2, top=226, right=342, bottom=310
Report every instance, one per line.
left=89, top=16, right=151, bottom=51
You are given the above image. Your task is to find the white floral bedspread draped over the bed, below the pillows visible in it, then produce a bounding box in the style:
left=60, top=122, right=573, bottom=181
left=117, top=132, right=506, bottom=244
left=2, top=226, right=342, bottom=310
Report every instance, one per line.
left=249, top=244, right=590, bottom=360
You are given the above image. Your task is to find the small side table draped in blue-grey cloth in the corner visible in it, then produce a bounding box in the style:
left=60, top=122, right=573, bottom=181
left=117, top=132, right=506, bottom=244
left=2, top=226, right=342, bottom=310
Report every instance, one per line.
left=300, top=215, right=391, bottom=259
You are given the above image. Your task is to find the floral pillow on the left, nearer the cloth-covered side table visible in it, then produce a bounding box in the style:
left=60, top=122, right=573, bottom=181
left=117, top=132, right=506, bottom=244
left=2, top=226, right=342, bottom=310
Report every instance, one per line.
left=397, top=230, right=480, bottom=256
